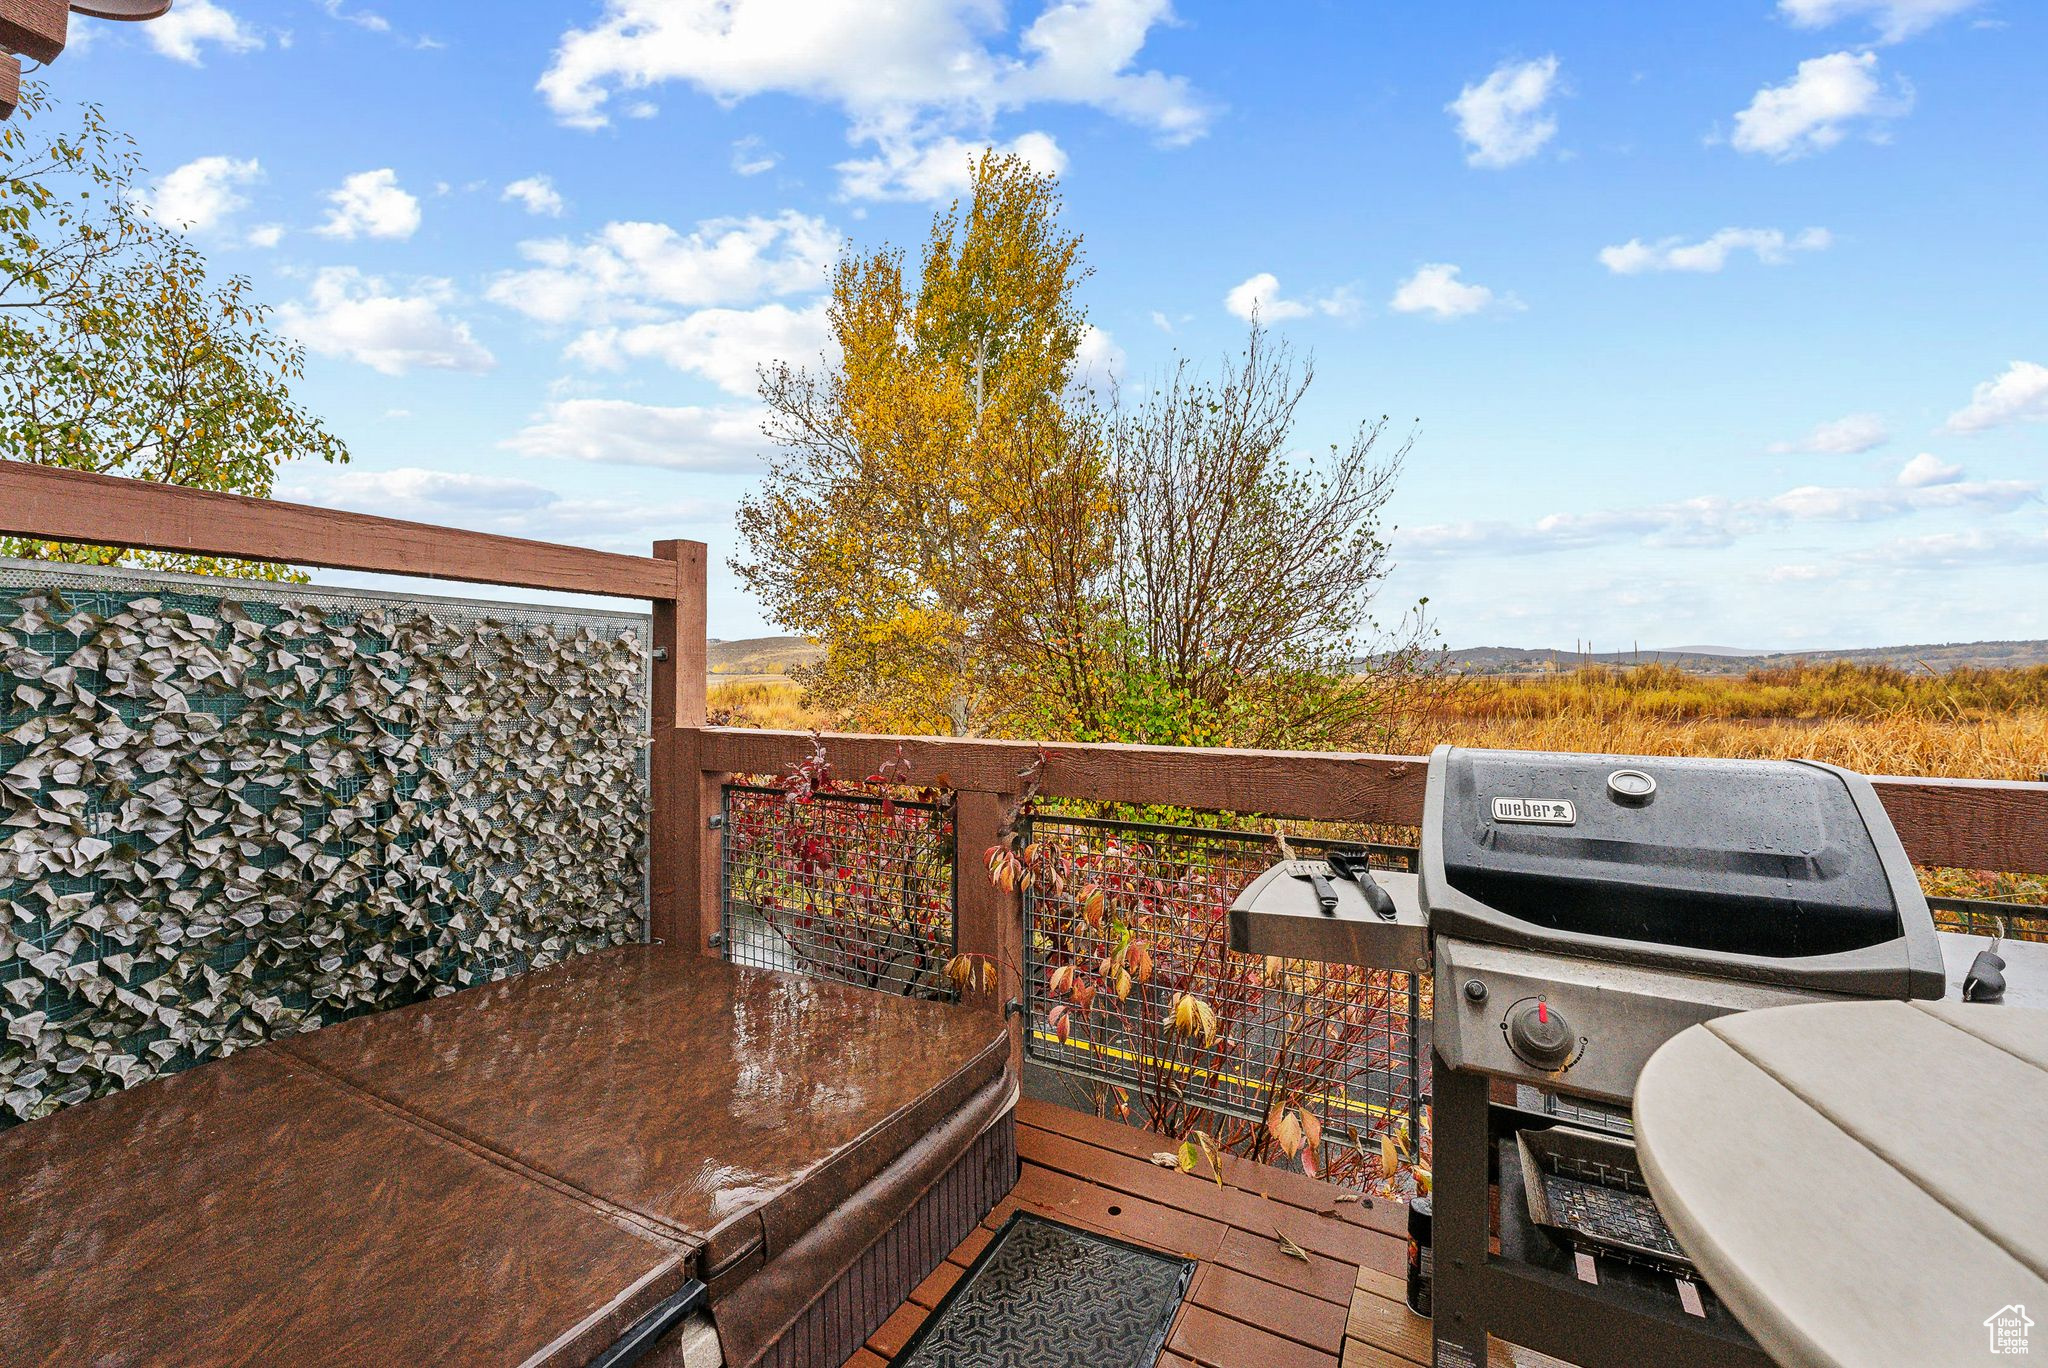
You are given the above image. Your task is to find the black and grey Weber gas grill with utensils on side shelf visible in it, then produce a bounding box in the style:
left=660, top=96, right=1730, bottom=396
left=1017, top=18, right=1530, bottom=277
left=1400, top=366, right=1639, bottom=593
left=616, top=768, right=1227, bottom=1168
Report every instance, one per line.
left=1231, top=745, right=1944, bottom=1368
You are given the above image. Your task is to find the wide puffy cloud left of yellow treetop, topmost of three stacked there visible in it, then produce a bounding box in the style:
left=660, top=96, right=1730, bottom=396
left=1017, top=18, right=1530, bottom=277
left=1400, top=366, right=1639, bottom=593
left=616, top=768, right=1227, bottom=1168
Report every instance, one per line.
left=487, top=209, right=840, bottom=326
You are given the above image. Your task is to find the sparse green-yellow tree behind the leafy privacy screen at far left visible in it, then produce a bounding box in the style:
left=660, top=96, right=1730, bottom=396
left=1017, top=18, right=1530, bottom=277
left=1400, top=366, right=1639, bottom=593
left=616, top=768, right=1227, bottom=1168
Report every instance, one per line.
left=0, top=84, right=348, bottom=580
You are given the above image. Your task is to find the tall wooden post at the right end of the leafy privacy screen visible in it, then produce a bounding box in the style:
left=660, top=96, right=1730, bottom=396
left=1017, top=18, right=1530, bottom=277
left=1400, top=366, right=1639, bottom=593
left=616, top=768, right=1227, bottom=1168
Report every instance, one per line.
left=647, top=541, right=709, bottom=942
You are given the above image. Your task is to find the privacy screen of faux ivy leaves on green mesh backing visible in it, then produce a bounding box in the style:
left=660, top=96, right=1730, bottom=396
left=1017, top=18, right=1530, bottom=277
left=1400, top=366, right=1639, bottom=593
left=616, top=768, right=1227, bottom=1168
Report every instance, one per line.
left=0, top=561, right=647, bottom=1126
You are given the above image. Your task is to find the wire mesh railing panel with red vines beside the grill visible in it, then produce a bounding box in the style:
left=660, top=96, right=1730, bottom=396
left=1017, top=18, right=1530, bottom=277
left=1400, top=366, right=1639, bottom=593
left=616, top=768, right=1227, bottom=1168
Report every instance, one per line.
left=1024, top=813, right=1430, bottom=1171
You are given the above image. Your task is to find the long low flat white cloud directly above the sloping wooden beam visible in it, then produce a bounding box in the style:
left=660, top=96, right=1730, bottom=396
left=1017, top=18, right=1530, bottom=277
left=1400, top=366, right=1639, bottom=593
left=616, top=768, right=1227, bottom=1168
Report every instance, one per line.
left=279, top=467, right=727, bottom=555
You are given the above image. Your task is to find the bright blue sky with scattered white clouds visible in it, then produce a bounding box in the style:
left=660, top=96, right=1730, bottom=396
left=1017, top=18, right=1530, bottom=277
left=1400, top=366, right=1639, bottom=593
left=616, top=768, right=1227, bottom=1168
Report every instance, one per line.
left=49, top=0, right=2048, bottom=649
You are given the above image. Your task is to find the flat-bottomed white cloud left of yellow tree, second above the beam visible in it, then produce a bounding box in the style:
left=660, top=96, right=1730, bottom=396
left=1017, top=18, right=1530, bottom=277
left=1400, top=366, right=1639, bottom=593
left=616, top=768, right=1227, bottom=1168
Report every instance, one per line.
left=504, top=399, right=762, bottom=471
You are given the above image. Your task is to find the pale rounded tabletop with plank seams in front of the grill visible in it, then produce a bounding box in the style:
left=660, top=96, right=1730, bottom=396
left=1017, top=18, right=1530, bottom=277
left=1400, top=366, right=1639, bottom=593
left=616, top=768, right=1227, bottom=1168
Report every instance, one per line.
left=1634, top=999, right=2048, bottom=1368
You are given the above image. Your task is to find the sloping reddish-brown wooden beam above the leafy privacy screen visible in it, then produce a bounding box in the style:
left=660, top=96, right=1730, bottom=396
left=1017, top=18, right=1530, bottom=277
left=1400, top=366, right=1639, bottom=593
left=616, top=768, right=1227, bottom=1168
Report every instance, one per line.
left=0, top=461, right=694, bottom=602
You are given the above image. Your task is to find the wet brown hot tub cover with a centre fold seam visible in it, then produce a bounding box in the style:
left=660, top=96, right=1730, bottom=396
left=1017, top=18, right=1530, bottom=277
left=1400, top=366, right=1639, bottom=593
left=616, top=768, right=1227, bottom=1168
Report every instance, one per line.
left=0, top=946, right=1010, bottom=1364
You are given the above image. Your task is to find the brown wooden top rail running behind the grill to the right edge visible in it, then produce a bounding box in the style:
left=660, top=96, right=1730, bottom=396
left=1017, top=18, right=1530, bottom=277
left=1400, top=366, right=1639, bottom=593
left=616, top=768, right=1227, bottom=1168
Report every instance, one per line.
left=694, top=727, right=2048, bottom=874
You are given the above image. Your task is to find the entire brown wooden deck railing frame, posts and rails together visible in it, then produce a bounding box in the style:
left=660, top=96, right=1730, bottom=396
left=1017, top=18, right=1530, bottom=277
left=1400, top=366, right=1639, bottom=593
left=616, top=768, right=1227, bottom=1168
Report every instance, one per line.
left=0, top=461, right=2048, bottom=1064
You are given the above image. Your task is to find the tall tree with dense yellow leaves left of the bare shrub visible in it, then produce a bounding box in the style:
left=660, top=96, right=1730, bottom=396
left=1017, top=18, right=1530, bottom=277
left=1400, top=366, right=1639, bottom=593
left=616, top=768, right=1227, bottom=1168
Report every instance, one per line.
left=733, top=152, right=1108, bottom=735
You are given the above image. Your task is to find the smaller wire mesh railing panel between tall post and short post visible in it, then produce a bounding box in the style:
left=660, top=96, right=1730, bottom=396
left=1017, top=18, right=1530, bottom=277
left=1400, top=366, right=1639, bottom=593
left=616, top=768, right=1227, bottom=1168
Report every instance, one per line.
left=719, top=784, right=958, bottom=1001
